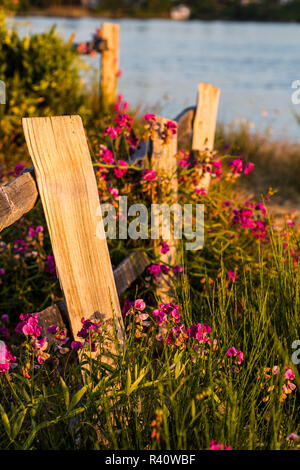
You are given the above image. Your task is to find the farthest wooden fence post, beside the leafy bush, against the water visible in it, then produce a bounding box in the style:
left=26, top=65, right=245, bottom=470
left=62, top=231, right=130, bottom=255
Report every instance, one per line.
left=100, top=23, right=120, bottom=111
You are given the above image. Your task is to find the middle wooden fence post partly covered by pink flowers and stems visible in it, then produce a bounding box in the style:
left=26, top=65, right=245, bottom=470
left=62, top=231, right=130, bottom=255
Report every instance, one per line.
left=151, top=116, right=178, bottom=303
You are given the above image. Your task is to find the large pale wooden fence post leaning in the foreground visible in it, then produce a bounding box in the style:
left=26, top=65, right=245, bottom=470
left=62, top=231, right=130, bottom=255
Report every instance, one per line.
left=23, top=116, right=123, bottom=352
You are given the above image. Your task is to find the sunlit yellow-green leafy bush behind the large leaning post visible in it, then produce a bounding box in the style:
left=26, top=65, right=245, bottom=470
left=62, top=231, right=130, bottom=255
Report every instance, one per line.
left=0, top=12, right=87, bottom=164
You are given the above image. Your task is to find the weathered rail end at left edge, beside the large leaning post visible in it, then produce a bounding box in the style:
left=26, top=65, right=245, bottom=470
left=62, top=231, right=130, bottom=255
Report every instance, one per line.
left=0, top=172, right=38, bottom=232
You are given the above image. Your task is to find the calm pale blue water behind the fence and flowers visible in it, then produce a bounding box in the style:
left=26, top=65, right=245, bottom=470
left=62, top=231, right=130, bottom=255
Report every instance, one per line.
left=11, top=17, right=300, bottom=140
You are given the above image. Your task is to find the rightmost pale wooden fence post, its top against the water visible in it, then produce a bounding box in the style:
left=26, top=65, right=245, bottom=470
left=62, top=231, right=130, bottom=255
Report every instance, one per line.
left=192, top=83, right=220, bottom=189
